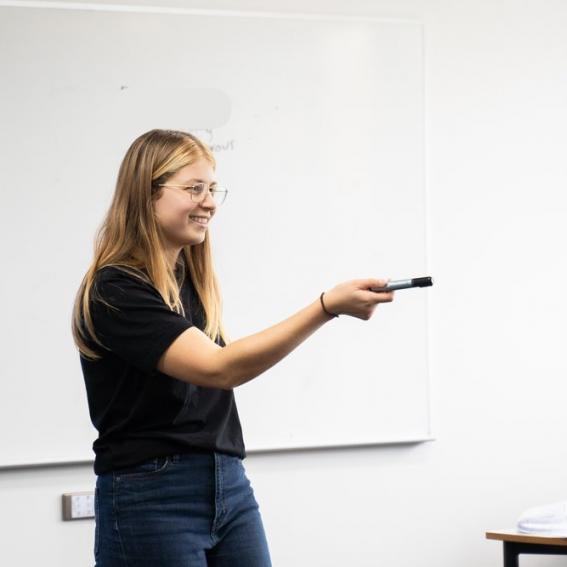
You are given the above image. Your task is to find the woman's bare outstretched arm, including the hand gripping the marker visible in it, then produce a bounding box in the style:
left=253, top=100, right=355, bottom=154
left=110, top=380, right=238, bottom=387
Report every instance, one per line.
left=157, top=278, right=394, bottom=390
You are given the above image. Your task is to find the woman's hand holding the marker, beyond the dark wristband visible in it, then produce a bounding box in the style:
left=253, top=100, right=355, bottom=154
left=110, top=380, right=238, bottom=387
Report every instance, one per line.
left=323, top=278, right=394, bottom=321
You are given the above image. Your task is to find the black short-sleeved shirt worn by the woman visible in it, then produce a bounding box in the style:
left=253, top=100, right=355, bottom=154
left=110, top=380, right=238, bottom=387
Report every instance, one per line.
left=80, top=264, right=246, bottom=475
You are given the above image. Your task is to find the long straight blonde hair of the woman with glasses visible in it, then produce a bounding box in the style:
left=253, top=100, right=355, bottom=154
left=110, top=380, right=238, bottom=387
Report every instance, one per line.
left=71, top=129, right=228, bottom=360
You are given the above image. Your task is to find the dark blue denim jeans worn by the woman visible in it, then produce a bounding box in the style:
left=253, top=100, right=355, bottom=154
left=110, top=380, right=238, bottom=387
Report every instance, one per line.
left=94, top=451, right=271, bottom=567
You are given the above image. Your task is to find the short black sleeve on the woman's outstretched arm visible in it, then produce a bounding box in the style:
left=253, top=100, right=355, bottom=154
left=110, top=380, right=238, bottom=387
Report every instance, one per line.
left=91, top=268, right=193, bottom=373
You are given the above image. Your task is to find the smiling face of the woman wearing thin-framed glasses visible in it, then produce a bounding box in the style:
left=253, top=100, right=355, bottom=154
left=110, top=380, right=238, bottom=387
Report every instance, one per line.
left=155, top=159, right=216, bottom=253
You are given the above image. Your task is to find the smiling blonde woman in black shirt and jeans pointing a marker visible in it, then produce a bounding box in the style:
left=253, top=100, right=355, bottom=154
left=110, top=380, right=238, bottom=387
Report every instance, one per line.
left=72, top=129, right=393, bottom=567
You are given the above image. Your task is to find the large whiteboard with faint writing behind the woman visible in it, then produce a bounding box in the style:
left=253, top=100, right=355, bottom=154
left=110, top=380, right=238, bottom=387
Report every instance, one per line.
left=0, top=3, right=430, bottom=467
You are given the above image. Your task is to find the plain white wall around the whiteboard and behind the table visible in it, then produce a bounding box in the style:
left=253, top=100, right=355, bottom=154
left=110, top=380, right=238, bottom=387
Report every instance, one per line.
left=0, top=0, right=567, bottom=567
